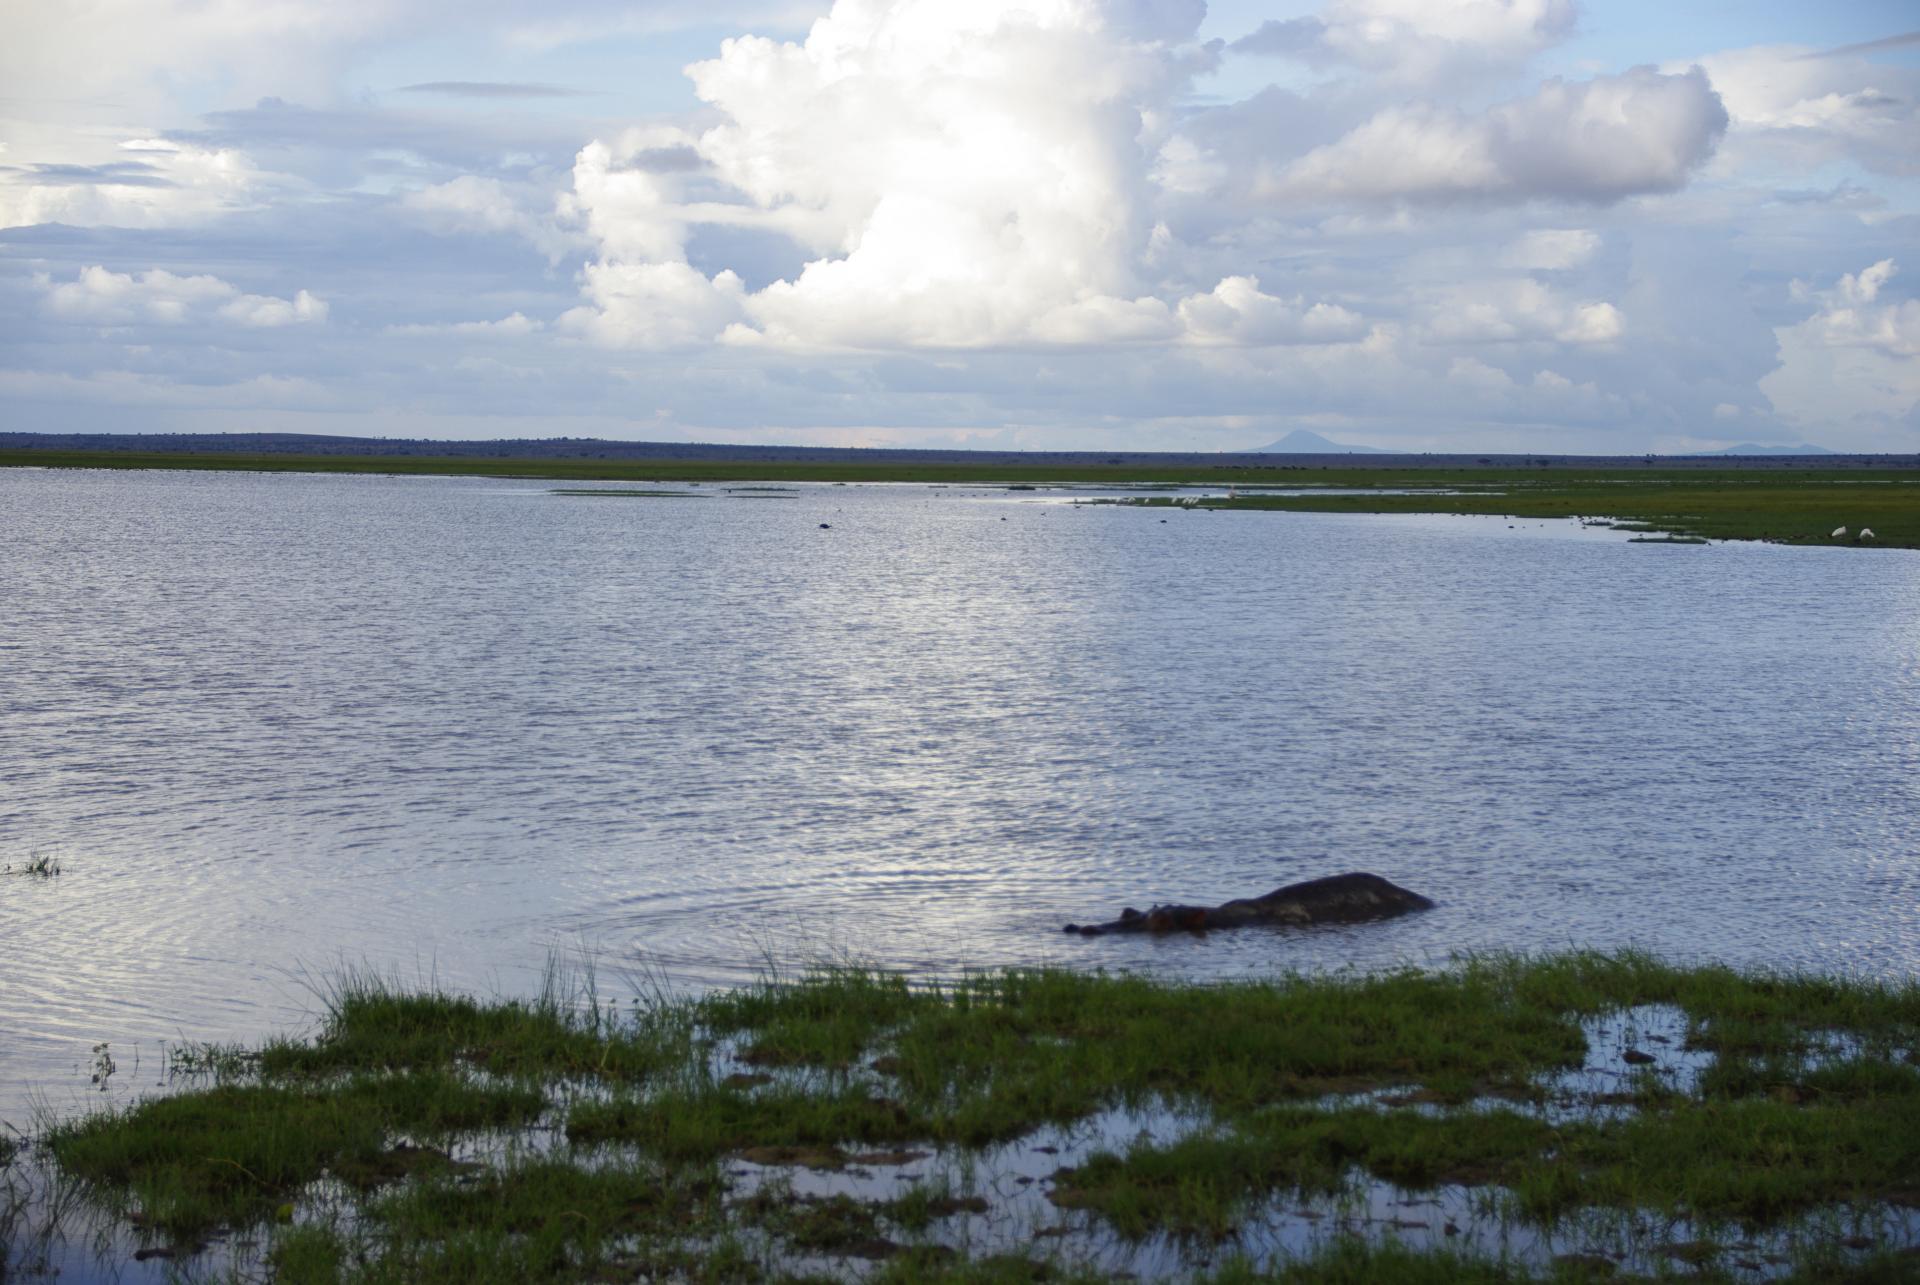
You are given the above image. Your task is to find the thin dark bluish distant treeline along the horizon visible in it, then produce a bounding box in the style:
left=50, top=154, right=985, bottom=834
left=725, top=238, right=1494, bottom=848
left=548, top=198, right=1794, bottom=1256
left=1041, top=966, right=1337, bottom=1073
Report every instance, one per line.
left=0, top=432, right=1920, bottom=471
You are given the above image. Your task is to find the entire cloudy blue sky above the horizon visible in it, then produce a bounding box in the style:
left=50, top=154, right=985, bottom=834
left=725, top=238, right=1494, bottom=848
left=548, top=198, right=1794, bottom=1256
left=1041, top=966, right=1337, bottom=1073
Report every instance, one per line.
left=0, top=0, right=1920, bottom=453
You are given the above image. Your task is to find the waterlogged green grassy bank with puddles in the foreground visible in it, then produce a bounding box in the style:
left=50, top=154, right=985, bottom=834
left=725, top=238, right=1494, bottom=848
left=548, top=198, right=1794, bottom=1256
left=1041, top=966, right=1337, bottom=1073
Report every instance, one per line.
left=15, top=953, right=1920, bottom=1281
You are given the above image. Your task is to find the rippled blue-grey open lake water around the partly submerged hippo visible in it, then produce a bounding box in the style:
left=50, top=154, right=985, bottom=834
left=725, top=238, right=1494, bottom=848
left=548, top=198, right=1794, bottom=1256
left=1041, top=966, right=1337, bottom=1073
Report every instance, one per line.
left=0, top=471, right=1920, bottom=1124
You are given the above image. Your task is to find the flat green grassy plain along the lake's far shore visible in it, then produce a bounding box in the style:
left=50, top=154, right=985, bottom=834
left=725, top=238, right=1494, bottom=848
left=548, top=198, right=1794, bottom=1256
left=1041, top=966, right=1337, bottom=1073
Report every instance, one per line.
left=0, top=451, right=1920, bottom=547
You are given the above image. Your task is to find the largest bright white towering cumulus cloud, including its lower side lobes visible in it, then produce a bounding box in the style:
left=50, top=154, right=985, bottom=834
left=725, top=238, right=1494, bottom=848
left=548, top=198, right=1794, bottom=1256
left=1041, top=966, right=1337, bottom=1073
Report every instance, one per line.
left=563, top=0, right=1363, bottom=350
